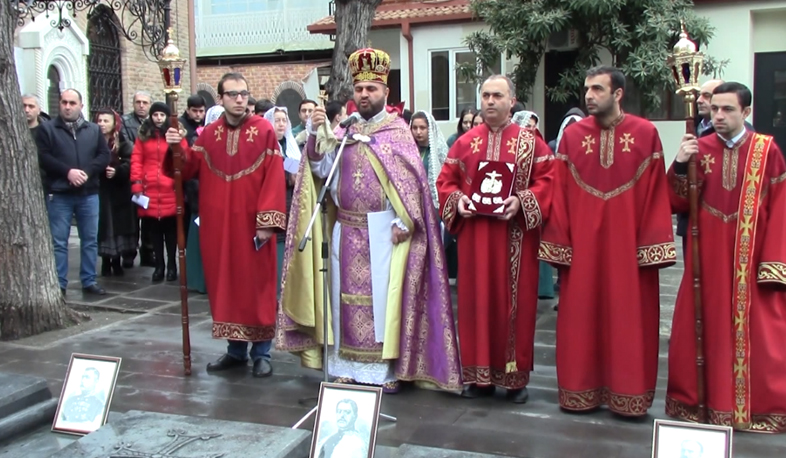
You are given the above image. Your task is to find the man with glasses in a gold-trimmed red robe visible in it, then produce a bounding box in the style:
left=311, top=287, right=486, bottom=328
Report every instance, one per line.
left=164, top=73, right=286, bottom=377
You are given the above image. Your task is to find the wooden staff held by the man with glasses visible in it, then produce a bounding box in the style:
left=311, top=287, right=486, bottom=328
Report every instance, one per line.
left=167, top=93, right=191, bottom=375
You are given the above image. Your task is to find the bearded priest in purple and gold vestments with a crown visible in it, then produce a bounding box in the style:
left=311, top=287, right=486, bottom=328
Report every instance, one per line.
left=276, top=49, right=461, bottom=393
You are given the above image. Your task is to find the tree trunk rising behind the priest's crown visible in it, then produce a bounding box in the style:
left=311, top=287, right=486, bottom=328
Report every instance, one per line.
left=326, top=0, right=382, bottom=103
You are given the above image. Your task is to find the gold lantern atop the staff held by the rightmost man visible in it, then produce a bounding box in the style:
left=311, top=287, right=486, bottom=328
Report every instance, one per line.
left=667, top=22, right=704, bottom=118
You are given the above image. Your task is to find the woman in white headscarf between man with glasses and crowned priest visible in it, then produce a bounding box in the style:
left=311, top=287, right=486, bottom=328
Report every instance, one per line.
left=265, top=107, right=301, bottom=294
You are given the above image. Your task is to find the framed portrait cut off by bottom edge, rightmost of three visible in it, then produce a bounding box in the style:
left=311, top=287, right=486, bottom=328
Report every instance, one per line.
left=652, top=420, right=733, bottom=458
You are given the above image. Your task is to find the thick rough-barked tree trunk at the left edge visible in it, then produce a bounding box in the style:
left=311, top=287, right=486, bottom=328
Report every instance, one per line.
left=0, top=1, right=87, bottom=340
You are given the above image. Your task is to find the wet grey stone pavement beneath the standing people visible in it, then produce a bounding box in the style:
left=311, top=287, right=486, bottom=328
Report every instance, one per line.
left=0, top=227, right=786, bottom=458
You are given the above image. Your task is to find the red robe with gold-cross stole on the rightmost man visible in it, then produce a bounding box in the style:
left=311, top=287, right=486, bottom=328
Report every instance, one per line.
left=666, top=133, right=786, bottom=432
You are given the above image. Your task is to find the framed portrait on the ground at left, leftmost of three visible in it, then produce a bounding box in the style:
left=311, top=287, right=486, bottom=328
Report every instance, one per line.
left=52, top=353, right=120, bottom=435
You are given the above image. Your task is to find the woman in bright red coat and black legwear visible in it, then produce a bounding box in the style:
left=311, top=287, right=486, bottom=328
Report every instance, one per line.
left=131, top=102, right=187, bottom=282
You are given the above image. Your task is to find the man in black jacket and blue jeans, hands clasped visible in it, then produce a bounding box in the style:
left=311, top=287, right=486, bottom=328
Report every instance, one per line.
left=36, top=89, right=110, bottom=295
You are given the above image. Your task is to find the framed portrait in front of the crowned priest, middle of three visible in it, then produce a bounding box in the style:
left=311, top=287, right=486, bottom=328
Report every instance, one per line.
left=309, top=382, right=382, bottom=458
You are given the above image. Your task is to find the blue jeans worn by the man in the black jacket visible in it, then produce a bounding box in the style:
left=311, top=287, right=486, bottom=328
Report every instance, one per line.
left=46, top=194, right=98, bottom=289
